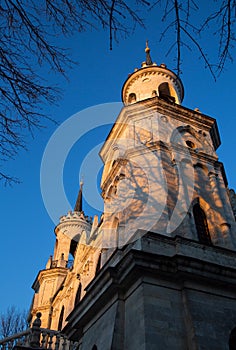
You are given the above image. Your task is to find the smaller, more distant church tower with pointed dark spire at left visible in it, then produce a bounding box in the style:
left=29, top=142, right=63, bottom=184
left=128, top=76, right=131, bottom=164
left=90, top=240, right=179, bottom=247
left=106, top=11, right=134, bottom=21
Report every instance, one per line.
left=31, top=182, right=95, bottom=330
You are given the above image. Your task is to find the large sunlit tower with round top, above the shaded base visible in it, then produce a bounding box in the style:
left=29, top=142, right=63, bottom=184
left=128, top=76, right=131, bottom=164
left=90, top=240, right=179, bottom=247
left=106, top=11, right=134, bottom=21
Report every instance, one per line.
left=100, top=45, right=236, bottom=249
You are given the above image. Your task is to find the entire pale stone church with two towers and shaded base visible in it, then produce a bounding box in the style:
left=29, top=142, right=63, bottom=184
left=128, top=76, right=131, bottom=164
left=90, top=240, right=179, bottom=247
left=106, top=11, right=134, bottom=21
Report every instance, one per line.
left=30, top=45, right=236, bottom=350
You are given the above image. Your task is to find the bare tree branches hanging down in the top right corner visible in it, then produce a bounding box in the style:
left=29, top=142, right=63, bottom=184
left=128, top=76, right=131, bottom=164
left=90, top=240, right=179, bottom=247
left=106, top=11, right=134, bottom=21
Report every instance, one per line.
left=151, top=0, right=236, bottom=79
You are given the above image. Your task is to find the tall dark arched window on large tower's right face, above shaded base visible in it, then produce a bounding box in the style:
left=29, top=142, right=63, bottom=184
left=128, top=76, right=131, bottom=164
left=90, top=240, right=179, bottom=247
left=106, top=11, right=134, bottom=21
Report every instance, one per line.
left=193, top=203, right=211, bottom=245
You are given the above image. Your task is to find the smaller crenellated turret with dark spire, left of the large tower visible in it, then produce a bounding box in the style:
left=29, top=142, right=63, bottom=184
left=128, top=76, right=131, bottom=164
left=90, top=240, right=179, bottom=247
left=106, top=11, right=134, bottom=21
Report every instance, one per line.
left=31, top=182, right=92, bottom=328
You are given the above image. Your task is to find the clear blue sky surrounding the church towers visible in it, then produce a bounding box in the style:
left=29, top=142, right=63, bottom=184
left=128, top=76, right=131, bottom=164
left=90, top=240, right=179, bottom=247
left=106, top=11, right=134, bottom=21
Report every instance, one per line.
left=0, top=4, right=236, bottom=312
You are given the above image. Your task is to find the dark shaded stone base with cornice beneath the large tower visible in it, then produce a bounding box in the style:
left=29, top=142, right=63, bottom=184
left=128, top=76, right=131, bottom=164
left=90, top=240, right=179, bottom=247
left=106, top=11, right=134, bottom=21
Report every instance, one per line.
left=64, top=233, right=236, bottom=350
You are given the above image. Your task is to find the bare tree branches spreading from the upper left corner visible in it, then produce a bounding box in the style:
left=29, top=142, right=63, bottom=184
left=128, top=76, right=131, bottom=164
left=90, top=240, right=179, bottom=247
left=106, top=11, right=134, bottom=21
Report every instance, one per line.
left=0, top=0, right=149, bottom=183
